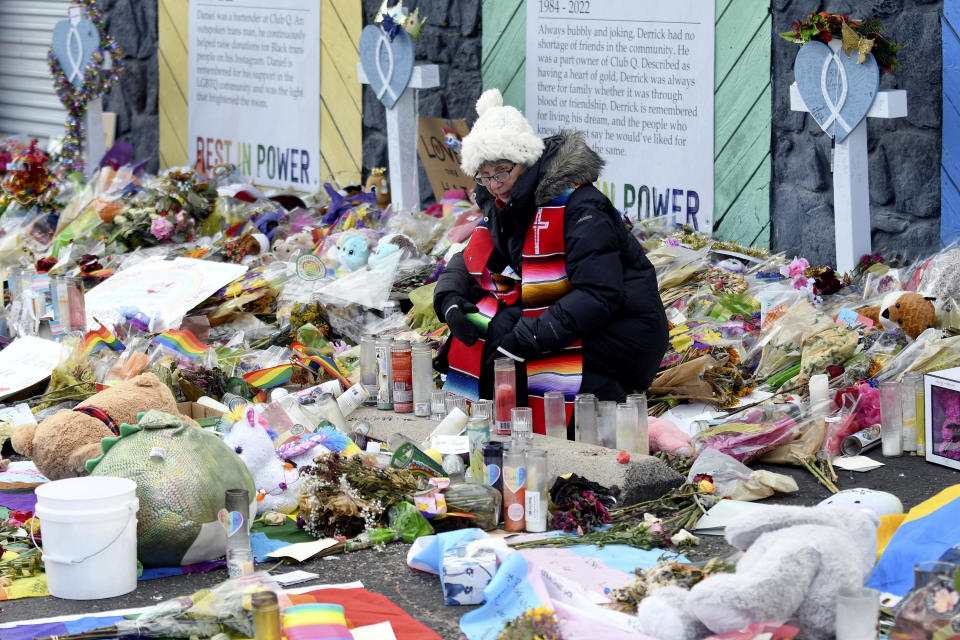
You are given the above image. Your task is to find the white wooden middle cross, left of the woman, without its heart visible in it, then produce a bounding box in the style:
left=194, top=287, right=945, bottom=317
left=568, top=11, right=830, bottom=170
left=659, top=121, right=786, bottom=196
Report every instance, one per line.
left=357, top=62, right=440, bottom=211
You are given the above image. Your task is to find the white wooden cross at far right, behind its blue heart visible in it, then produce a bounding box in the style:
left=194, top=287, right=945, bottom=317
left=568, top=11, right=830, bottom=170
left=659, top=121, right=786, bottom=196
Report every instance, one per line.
left=790, top=83, right=907, bottom=274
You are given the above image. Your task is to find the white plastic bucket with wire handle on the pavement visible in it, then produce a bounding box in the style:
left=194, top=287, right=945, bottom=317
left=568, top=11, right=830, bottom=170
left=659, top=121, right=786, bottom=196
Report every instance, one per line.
left=36, top=476, right=140, bottom=600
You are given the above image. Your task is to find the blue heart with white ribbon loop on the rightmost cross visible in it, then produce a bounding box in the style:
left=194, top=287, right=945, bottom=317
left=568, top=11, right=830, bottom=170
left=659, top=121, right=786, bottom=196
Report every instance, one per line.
left=793, top=40, right=880, bottom=142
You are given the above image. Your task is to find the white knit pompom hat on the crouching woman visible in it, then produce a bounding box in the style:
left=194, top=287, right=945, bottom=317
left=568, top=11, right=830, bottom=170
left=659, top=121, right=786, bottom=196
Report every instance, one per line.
left=460, top=89, right=543, bottom=176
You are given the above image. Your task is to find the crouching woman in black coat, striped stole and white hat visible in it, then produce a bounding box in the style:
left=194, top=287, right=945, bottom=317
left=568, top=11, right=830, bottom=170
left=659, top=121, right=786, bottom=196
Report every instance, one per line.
left=434, top=89, right=667, bottom=433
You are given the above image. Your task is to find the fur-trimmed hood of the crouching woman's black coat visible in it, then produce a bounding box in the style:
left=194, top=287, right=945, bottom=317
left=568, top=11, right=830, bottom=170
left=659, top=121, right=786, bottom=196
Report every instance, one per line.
left=532, top=131, right=604, bottom=207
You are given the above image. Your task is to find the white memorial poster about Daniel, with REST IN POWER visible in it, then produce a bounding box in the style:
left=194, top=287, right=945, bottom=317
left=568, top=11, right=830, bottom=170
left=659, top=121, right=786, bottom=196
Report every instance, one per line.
left=188, top=0, right=322, bottom=192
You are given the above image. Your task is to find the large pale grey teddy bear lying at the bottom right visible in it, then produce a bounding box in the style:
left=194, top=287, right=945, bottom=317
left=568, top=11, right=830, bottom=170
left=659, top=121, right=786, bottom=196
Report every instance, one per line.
left=637, top=506, right=879, bottom=640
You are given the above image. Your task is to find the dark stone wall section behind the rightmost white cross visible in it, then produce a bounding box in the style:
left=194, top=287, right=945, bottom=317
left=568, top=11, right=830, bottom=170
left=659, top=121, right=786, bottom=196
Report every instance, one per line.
left=771, top=0, right=943, bottom=265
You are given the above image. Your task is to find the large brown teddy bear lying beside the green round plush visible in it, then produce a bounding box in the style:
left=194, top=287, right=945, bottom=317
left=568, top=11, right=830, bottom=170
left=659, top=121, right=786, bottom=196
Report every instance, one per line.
left=10, top=373, right=196, bottom=480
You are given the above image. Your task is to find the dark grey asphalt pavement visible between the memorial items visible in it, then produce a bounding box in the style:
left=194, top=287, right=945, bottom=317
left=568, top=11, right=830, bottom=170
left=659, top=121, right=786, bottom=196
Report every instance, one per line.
left=0, top=447, right=960, bottom=640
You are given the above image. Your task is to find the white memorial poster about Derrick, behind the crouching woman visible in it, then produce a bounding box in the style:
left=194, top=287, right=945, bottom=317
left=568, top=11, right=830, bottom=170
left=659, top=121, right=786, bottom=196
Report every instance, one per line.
left=526, top=0, right=714, bottom=234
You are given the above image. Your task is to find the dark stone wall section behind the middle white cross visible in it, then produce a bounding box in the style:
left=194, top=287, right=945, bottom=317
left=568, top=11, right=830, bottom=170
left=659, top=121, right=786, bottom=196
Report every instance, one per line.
left=363, top=0, right=481, bottom=204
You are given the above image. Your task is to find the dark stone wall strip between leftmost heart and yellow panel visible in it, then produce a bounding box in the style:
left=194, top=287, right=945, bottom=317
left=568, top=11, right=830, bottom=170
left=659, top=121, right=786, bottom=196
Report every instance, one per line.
left=97, top=0, right=159, bottom=171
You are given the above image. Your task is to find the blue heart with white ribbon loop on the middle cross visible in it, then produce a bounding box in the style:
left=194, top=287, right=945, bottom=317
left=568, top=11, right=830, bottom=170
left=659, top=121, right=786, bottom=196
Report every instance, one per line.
left=360, top=24, right=414, bottom=109
